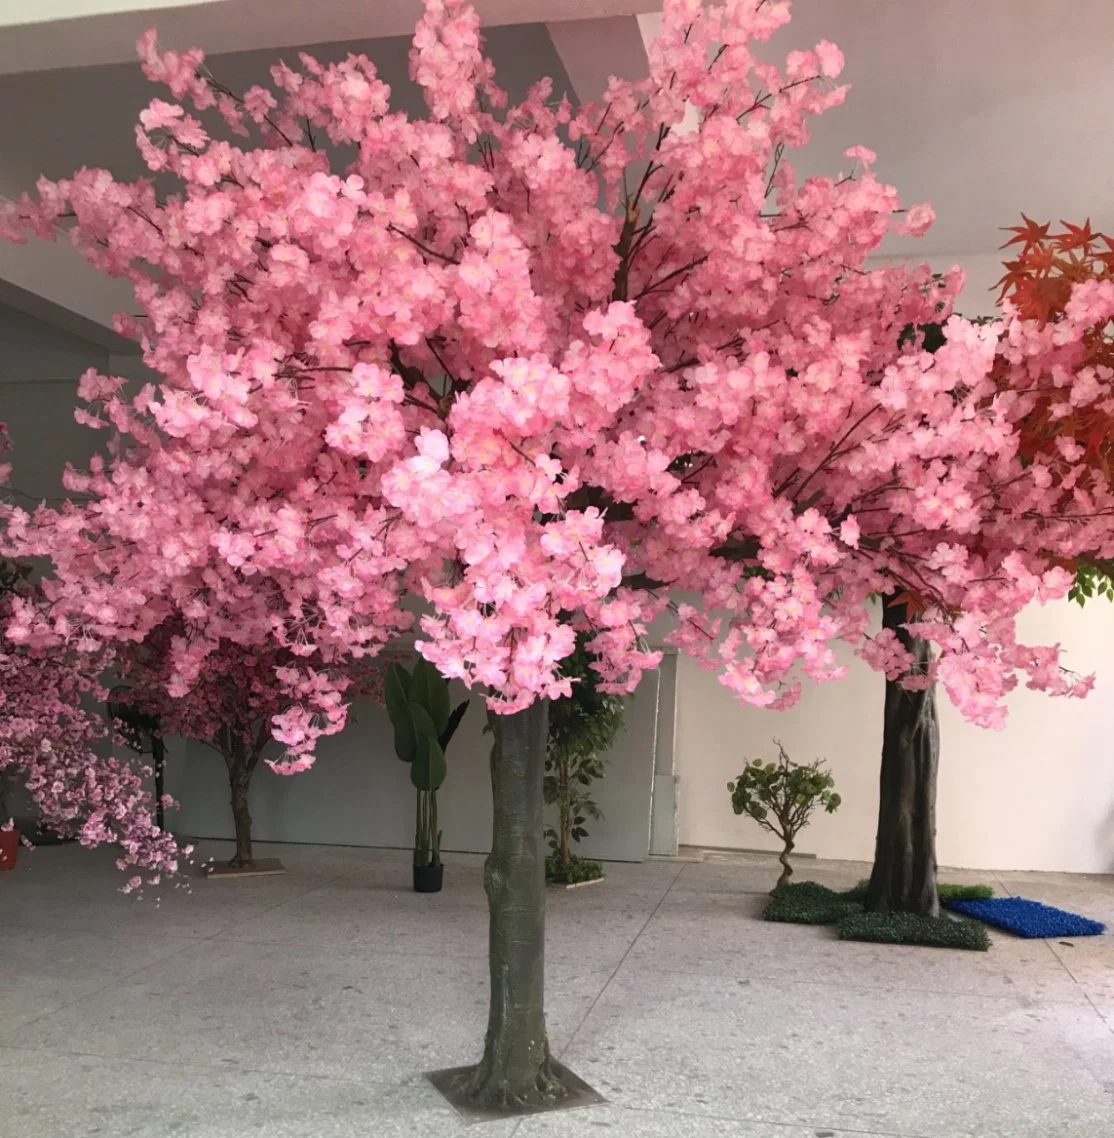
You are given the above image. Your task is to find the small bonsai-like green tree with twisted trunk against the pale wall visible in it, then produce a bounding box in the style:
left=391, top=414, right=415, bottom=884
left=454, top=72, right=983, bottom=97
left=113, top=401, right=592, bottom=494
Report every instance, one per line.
left=727, top=739, right=841, bottom=889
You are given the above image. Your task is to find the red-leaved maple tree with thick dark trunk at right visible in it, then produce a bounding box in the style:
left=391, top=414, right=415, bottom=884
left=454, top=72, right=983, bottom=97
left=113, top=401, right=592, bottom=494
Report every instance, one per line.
left=866, top=235, right=1114, bottom=915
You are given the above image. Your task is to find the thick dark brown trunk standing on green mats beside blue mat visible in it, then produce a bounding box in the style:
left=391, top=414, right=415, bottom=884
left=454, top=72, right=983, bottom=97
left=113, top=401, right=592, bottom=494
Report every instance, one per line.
left=866, top=596, right=940, bottom=916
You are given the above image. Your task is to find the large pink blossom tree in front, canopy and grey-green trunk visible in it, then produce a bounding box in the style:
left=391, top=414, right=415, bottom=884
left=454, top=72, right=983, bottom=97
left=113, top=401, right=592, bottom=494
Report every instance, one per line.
left=2, top=0, right=1112, bottom=1106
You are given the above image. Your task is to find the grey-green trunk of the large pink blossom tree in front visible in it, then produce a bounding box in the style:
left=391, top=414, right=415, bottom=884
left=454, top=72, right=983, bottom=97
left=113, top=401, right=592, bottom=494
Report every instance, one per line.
left=462, top=701, right=564, bottom=1108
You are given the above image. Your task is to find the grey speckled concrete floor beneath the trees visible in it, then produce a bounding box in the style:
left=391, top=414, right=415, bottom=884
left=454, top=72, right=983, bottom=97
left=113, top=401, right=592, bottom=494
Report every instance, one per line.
left=0, top=843, right=1114, bottom=1138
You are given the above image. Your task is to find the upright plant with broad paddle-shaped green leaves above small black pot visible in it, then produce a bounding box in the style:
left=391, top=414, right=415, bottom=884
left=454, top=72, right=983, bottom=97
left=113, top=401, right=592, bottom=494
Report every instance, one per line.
left=385, top=658, right=468, bottom=868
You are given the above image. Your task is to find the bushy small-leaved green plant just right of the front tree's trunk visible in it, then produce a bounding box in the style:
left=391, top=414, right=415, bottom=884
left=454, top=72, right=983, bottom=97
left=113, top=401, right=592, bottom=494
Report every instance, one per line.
left=545, top=635, right=624, bottom=884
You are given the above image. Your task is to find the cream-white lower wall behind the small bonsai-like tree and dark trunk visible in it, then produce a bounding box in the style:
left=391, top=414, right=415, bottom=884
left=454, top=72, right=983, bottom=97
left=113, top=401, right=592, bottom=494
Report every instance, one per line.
left=677, top=601, right=1114, bottom=873
